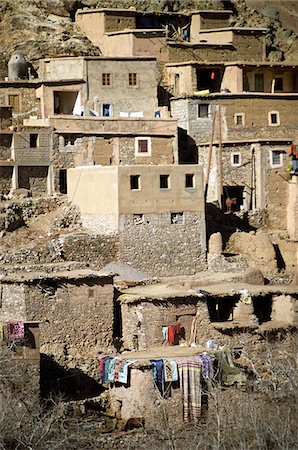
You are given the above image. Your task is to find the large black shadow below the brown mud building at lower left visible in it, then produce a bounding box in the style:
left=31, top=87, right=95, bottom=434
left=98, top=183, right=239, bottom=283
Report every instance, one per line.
left=40, top=354, right=105, bottom=401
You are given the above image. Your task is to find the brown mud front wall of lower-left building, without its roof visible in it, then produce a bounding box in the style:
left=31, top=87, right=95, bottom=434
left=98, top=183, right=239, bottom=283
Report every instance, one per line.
left=26, top=278, right=114, bottom=357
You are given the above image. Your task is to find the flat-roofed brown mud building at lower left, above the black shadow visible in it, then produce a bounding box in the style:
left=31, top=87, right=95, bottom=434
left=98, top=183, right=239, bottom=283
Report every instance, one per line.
left=0, top=269, right=114, bottom=357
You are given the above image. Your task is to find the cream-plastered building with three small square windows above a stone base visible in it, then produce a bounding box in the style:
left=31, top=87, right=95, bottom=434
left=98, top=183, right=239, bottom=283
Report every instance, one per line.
left=67, top=164, right=206, bottom=276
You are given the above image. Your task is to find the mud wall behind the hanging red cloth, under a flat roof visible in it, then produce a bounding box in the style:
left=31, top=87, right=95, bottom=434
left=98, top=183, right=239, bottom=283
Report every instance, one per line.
left=121, top=297, right=210, bottom=350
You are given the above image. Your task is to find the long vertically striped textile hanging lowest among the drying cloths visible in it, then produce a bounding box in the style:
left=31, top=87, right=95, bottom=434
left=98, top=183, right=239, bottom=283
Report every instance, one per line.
left=176, top=356, right=201, bottom=422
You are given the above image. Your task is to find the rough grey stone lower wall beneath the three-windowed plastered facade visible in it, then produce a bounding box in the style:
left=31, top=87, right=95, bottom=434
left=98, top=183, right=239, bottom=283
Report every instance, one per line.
left=119, top=211, right=206, bottom=276
